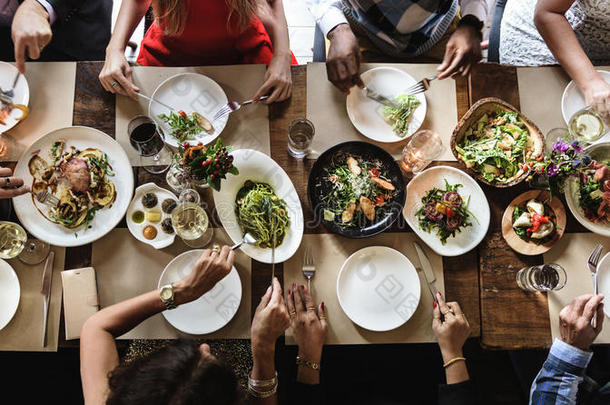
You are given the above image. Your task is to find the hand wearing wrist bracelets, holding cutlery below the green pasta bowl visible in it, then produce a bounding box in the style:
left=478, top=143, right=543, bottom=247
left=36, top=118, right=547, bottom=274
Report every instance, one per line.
left=251, top=277, right=290, bottom=355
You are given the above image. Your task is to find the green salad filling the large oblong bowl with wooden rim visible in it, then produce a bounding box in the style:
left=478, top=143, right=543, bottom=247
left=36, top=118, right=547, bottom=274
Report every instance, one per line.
left=455, top=109, right=532, bottom=183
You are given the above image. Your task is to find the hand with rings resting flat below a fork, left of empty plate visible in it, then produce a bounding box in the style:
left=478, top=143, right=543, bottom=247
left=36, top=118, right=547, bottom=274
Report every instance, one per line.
left=286, top=283, right=328, bottom=363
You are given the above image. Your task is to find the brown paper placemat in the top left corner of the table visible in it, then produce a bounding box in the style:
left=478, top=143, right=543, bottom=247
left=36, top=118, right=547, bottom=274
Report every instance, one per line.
left=1, top=62, right=76, bottom=161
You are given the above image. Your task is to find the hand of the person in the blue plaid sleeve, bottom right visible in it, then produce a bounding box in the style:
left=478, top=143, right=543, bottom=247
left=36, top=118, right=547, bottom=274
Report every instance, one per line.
left=559, top=294, right=604, bottom=350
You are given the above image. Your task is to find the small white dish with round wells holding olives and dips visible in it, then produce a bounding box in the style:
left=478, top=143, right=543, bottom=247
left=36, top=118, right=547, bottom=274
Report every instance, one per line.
left=125, top=183, right=178, bottom=249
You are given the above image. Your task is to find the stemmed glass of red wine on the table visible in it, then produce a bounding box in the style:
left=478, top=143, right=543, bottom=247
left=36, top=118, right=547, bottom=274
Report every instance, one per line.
left=127, top=115, right=172, bottom=174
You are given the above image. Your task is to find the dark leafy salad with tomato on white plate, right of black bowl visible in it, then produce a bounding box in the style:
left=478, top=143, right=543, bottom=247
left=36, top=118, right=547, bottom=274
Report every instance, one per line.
left=415, top=180, right=476, bottom=245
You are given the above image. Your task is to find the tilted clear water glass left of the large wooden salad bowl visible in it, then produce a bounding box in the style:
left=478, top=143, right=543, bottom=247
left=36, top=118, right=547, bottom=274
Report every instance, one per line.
left=400, top=129, right=443, bottom=175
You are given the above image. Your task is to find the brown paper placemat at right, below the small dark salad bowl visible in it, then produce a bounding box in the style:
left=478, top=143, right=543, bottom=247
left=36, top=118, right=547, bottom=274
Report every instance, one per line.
left=544, top=233, right=610, bottom=343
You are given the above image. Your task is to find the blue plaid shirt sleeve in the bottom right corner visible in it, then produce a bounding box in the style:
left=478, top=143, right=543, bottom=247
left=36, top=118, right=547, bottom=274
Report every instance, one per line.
left=530, top=339, right=610, bottom=405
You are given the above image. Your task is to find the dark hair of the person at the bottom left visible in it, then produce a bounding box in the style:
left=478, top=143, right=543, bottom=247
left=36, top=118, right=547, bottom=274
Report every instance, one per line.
left=106, top=339, right=243, bottom=405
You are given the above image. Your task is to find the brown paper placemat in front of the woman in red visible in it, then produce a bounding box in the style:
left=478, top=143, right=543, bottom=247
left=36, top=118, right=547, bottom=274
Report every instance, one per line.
left=115, top=65, right=271, bottom=166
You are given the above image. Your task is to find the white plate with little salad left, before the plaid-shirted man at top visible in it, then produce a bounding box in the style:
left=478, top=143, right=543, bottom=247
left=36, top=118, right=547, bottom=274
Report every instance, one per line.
left=346, top=67, right=427, bottom=142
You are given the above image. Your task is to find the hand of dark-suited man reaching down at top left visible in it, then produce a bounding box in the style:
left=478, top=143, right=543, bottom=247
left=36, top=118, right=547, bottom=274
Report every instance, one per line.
left=11, top=0, right=53, bottom=74
